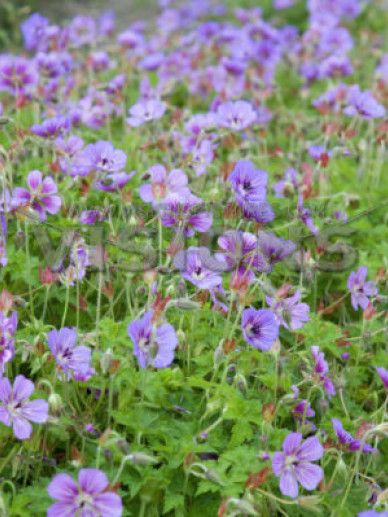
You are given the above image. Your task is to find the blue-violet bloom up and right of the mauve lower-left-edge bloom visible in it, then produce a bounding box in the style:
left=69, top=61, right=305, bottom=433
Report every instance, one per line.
left=47, top=327, right=93, bottom=380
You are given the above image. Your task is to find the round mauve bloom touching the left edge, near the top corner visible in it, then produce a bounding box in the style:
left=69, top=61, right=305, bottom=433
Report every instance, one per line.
left=0, top=55, right=38, bottom=97
